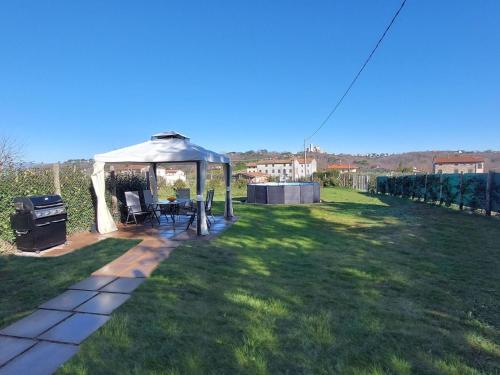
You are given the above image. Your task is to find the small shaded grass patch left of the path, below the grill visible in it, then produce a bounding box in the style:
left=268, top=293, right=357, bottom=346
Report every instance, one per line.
left=0, top=239, right=139, bottom=327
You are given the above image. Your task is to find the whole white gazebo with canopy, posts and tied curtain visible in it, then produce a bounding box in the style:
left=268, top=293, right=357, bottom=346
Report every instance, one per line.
left=92, top=131, right=233, bottom=235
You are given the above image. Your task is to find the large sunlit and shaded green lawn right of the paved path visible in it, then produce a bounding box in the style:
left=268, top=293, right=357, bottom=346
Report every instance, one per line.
left=55, top=190, right=500, bottom=375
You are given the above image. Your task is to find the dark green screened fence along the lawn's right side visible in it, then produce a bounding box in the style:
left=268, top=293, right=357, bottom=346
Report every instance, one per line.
left=376, top=172, right=500, bottom=215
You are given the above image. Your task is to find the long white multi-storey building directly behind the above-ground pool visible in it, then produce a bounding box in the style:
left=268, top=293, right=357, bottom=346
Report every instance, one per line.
left=247, top=158, right=317, bottom=180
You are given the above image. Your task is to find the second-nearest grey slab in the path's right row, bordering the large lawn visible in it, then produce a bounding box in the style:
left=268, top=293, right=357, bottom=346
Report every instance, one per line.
left=39, top=313, right=109, bottom=344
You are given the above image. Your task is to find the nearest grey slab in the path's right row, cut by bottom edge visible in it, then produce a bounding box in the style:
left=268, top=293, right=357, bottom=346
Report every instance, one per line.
left=0, top=342, right=78, bottom=375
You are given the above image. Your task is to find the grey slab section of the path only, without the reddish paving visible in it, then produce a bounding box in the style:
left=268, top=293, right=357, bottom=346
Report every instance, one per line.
left=0, top=276, right=137, bottom=375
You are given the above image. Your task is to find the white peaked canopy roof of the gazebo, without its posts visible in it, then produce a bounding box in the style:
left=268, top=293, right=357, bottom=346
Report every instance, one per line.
left=94, top=131, right=230, bottom=163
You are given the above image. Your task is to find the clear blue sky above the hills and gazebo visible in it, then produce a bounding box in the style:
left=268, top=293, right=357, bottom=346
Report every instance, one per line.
left=0, top=0, right=500, bottom=162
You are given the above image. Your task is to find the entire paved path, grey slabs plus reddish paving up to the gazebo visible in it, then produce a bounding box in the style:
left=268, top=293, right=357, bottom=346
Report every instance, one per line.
left=0, top=216, right=236, bottom=375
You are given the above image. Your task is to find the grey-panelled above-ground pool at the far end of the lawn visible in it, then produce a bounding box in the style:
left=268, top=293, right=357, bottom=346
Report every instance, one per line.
left=247, top=182, right=319, bottom=204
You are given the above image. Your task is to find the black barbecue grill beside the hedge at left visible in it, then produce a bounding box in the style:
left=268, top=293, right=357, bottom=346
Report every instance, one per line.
left=10, top=195, right=67, bottom=251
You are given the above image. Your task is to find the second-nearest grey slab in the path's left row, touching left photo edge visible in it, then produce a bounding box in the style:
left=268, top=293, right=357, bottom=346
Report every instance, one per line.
left=0, top=310, right=72, bottom=338
